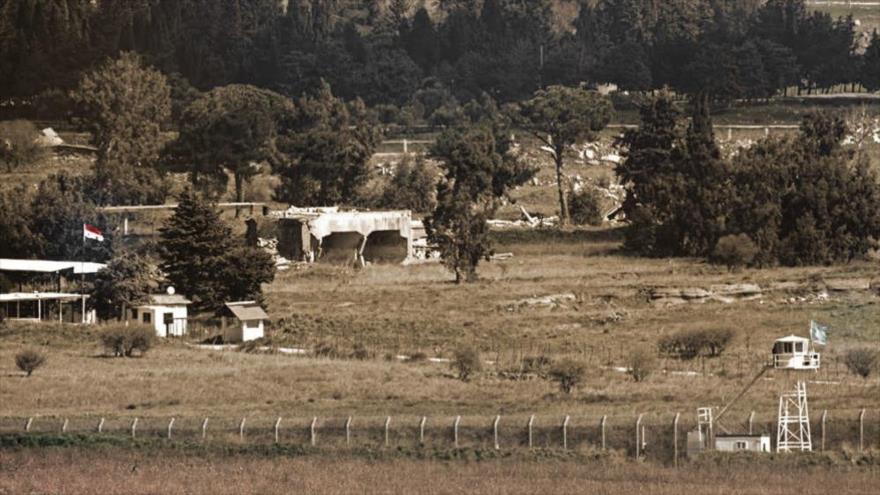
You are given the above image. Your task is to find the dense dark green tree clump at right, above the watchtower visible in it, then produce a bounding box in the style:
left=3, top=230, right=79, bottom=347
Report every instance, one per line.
left=618, top=94, right=880, bottom=265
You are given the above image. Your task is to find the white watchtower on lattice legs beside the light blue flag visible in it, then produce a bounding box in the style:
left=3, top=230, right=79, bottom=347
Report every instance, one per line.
left=772, top=335, right=820, bottom=452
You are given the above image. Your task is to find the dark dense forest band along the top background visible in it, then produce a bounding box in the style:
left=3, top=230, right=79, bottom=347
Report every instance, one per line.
left=0, top=0, right=880, bottom=114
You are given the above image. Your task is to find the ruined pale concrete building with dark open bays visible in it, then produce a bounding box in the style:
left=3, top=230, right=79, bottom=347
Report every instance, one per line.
left=269, top=207, right=413, bottom=264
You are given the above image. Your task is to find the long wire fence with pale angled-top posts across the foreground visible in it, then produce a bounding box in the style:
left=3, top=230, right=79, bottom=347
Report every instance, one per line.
left=0, top=409, right=880, bottom=464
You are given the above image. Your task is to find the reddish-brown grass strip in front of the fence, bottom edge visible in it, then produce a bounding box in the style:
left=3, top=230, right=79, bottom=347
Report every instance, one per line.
left=0, top=448, right=880, bottom=495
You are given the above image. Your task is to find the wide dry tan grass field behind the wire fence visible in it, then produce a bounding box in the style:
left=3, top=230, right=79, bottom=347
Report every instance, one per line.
left=0, top=230, right=880, bottom=432
